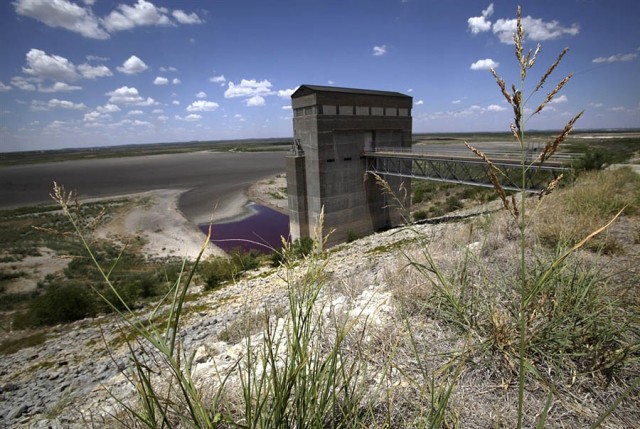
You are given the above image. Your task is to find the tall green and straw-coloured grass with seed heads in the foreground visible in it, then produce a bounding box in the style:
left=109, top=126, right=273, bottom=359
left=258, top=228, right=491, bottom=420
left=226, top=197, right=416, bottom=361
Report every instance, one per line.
left=46, top=5, right=640, bottom=428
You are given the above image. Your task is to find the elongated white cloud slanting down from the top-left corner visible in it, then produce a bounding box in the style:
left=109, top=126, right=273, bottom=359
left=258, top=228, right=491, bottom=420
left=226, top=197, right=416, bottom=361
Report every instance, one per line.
left=13, top=0, right=109, bottom=39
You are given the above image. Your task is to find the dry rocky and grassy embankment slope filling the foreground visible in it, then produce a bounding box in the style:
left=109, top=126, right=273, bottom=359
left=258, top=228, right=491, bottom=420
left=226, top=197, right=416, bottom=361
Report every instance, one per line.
left=0, top=166, right=640, bottom=428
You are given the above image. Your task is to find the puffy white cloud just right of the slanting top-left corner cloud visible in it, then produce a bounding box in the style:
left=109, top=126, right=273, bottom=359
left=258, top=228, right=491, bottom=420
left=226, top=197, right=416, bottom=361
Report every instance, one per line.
left=103, top=0, right=172, bottom=32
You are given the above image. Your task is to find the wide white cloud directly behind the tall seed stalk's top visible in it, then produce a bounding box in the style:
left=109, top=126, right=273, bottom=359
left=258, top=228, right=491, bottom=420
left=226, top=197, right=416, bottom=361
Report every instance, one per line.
left=493, top=16, right=580, bottom=45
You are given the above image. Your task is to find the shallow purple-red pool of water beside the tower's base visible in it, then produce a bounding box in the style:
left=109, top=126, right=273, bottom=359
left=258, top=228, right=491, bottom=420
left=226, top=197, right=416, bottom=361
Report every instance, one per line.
left=199, top=203, right=289, bottom=253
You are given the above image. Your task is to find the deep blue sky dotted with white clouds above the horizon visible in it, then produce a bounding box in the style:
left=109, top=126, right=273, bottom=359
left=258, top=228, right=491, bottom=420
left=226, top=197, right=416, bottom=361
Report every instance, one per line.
left=0, top=0, right=640, bottom=152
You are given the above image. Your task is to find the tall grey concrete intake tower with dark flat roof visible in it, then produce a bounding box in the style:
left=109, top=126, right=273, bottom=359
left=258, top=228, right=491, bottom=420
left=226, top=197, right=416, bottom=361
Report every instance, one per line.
left=286, top=85, right=413, bottom=245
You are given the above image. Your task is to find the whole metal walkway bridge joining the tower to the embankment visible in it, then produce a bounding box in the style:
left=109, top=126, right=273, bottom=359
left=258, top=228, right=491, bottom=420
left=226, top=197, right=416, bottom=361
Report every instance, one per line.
left=364, top=148, right=573, bottom=192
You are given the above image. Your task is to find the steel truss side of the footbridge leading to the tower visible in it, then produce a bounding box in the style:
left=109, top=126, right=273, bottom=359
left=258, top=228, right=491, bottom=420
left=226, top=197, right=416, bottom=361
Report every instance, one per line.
left=366, top=153, right=570, bottom=192
